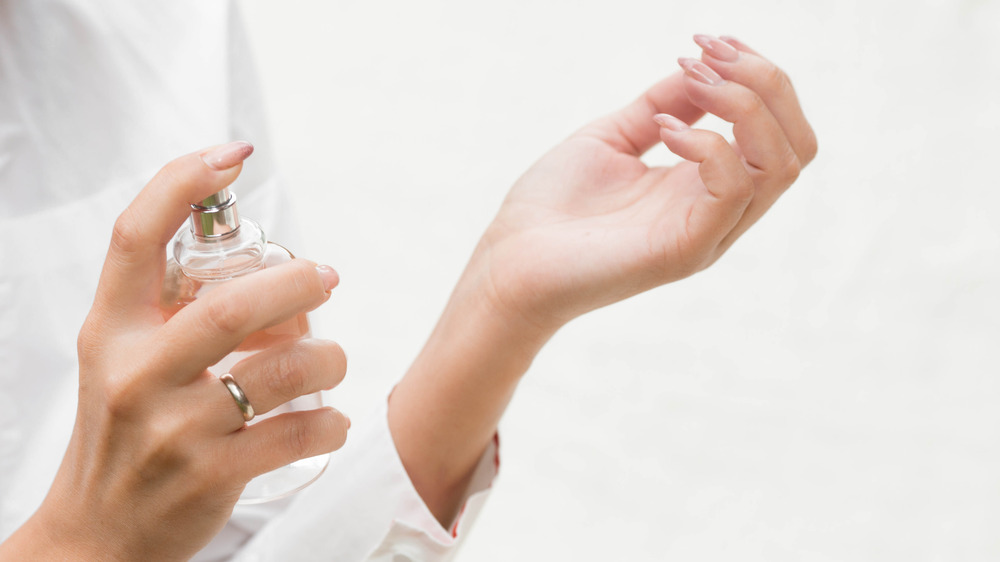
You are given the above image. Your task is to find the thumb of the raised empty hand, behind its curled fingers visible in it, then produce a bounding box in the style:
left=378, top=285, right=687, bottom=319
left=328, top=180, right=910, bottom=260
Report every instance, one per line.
left=577, top=72, right=705, bottom=156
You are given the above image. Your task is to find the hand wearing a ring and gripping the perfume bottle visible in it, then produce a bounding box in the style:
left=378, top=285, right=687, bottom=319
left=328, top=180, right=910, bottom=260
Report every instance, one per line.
left=0, top=143, right=350, bottom=560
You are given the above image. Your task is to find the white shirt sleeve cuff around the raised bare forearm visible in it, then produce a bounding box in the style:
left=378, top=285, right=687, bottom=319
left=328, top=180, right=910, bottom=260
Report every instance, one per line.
left=204, top=394, right=499, bottom=562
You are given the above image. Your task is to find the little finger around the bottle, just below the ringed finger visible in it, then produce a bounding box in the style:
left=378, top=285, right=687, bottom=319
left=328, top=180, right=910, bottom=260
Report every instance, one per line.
left=226, top=408, right=351, bottom=480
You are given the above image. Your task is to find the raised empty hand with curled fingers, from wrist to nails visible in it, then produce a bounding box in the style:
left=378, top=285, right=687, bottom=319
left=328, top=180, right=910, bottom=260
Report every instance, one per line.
left=473, top=36, right=816, bottom=332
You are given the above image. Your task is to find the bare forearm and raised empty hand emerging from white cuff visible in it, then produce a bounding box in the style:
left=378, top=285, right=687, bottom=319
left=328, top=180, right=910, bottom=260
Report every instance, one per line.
left=389, top=36, right=816, bottom=525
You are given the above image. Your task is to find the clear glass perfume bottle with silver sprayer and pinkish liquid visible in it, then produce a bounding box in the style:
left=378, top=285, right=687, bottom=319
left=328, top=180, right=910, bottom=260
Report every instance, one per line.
left=160, top=188, right=330, bottom=504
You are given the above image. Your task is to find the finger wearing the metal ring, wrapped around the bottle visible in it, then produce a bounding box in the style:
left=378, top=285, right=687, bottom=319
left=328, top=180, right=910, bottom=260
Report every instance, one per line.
left=215, top=339, right=347, bottom=432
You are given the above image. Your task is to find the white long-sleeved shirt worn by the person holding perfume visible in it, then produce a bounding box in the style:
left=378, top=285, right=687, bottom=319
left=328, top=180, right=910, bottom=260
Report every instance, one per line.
left=0, top=0, right=498, bottom=562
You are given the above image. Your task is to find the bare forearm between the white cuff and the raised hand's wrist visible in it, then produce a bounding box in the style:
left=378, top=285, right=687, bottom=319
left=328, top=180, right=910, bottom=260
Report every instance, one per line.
left=389, top=247, right=554, bottom=526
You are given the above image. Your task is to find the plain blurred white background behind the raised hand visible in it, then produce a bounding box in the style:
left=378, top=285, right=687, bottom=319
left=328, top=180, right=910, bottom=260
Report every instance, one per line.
left=244, top=0, right=1000, bottom=562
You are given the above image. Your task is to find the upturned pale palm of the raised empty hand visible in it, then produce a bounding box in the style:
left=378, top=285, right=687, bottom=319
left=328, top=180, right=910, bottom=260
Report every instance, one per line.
left=490, top=132, right=710, bottom=322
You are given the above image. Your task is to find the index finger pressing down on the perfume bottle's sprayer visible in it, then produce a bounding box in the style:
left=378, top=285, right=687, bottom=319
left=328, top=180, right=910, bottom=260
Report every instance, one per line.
left=97, top=141, right=253, bottom=311
